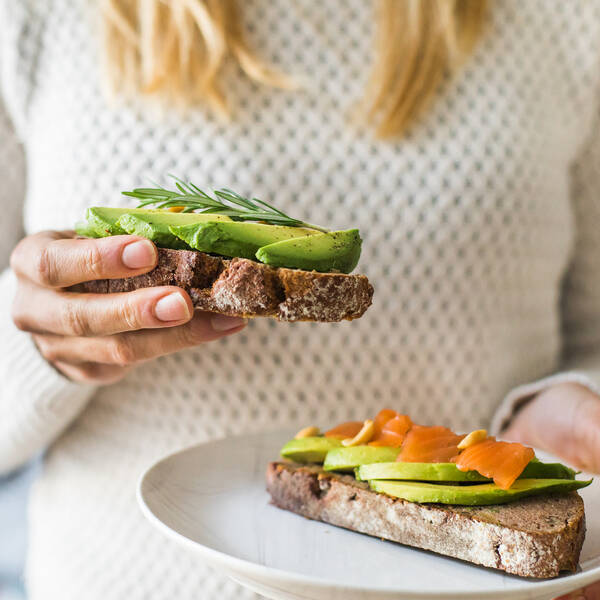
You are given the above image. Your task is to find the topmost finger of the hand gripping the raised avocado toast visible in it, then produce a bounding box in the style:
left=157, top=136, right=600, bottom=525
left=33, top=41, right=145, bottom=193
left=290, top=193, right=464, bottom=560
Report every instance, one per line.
left=11, top=231, right=158, bottom=288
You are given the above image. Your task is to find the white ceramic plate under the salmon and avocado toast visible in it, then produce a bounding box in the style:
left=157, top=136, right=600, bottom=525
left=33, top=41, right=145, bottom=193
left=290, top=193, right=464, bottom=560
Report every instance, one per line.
left=138, top=432, right=600, bottom=600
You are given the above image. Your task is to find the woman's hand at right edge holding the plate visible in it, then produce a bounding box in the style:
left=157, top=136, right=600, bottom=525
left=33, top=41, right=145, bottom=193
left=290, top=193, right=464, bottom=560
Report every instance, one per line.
left=502, top=383, right=600, bottom=600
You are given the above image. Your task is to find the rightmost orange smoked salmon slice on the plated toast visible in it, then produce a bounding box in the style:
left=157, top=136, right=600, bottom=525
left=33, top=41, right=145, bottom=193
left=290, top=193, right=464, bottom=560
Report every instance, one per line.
left=455, top=439, right=535, bottom=490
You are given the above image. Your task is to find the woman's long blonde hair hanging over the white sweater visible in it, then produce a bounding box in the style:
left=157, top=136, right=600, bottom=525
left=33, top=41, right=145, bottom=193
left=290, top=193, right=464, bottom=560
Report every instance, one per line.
left=100, top=0, right=486, bottom=138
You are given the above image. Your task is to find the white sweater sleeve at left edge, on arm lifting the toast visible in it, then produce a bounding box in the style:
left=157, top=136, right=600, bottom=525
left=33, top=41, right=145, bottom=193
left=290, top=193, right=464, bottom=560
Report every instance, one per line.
left=0, top=85, right=93, bottom=474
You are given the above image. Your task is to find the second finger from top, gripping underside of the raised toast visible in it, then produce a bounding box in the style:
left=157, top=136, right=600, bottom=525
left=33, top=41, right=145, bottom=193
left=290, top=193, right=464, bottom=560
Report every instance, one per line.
left=12, top=281, right=194, bottom=337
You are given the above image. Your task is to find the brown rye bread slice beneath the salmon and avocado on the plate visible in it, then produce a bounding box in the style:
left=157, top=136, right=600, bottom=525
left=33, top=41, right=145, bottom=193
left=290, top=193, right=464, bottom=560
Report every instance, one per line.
left=267, top=462, right=585, bottom=578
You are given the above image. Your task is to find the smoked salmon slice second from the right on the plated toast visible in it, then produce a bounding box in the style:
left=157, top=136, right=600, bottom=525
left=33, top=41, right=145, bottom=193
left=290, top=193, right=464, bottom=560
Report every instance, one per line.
left=397, top=425, right=465, bottom=462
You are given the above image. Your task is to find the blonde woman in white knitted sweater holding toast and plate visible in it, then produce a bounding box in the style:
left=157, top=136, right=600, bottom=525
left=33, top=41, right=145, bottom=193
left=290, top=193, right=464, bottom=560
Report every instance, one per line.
left=0, top=0, right=600, bottom=599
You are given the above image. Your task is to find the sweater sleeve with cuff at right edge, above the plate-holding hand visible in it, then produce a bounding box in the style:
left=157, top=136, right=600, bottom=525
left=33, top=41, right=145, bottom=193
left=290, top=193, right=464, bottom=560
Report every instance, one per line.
left=491, top=110, right=600, bottom=433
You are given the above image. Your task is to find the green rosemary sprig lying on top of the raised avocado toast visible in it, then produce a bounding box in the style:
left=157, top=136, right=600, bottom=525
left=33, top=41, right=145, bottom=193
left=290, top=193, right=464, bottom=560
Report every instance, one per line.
left=121, top=175, right=329, bottom=232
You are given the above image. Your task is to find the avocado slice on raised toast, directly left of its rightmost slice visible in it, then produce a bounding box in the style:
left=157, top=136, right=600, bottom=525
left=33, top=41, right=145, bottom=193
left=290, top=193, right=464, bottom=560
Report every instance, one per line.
left=170, top=219, right=317, bottom=260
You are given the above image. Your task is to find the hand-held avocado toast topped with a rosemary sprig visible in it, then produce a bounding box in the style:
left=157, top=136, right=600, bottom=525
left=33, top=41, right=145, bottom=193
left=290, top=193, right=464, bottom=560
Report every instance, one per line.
left=76, top=179, right=373, bottom=321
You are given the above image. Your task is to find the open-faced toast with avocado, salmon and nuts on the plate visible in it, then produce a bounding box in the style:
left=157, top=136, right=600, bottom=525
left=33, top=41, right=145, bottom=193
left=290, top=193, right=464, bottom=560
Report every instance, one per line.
left=267, top=409, right=591, bottom=578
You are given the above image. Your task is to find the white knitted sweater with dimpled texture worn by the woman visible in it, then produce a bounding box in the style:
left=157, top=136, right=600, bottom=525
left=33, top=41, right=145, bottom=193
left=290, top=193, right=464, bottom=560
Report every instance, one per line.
left=0, top=0, right=600, bottom=600
